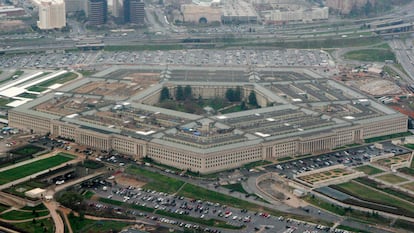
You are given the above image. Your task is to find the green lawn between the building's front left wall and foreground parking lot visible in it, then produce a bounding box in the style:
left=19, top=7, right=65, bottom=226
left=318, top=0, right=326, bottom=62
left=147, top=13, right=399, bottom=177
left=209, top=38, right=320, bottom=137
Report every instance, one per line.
left=126, top=166, right=184, bottom=193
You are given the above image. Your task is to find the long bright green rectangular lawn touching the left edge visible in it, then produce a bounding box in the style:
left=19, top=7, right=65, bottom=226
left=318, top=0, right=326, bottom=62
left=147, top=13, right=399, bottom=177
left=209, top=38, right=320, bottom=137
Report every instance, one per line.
left=0, top=153, right=74, bottom=184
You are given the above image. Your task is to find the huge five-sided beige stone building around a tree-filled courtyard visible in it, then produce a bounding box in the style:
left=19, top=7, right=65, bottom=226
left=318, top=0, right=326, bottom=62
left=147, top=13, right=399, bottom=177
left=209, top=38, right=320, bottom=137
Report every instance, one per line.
left=8, top=67, right=408, bottom=173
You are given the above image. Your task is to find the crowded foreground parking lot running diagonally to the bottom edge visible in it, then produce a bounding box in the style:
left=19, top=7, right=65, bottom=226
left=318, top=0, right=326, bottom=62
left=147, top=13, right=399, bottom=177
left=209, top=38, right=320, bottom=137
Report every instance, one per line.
left=90, top=182, right=334, bottom=233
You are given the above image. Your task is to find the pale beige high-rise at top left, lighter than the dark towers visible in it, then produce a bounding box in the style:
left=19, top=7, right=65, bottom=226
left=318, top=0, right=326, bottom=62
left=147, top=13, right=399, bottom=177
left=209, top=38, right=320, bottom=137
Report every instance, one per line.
left=37, top=0, right=66, bottom=30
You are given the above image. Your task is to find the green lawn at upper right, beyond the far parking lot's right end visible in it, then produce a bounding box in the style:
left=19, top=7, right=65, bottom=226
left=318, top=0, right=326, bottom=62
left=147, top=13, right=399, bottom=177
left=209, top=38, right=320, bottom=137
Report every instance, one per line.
left=344, top=49, right=396, bottom=62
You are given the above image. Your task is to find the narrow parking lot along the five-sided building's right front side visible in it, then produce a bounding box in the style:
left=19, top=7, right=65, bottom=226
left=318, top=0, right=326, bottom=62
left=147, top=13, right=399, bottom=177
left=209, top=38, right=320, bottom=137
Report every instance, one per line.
left=266, top=142, right=410, bottom=179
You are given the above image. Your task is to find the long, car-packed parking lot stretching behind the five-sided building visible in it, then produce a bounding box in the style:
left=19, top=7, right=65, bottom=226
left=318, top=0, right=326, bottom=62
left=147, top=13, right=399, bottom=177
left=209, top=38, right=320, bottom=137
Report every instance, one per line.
left=0, top=49, right=329, bottom=68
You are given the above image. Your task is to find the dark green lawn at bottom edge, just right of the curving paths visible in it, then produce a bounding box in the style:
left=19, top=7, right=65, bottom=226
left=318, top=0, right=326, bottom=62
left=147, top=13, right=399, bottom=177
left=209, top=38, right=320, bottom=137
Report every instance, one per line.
left=68, top=216, right=132, bottom=233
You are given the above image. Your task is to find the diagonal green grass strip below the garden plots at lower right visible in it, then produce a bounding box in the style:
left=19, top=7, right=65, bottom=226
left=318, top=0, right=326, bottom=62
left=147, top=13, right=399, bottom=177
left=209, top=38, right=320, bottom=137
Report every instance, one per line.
left=336, top=181, right=414, bottom=212
